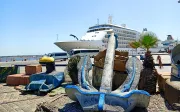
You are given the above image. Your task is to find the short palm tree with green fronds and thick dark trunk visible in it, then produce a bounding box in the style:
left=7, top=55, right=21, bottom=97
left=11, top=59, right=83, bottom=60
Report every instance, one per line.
left=131, top=32, right=158, bottom=93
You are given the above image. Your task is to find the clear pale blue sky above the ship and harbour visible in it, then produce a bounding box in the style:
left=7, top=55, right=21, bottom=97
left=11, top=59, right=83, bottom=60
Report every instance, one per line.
left=0, top=0, right=180, bottom=56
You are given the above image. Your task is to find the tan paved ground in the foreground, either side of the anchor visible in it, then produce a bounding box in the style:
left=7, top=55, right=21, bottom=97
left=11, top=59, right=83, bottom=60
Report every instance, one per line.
left=0, top=81, right=178, bottom=112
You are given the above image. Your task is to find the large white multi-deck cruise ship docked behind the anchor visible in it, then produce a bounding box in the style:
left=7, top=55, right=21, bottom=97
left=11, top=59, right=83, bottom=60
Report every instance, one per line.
left=54, top=17, right=162, bottom=54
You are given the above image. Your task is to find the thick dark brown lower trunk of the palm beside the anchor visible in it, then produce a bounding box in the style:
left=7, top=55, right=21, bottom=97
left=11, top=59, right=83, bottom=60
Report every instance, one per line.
left=138, top=68, right=157, bottom=94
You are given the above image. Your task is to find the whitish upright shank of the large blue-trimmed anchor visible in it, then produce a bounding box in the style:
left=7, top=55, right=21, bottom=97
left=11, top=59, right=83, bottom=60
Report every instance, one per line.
left=100, top=32, right=116, bottom=93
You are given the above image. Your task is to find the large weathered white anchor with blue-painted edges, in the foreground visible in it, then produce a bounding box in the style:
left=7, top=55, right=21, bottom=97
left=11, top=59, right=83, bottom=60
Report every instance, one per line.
left=65, top=32, right=150, bottom=112
